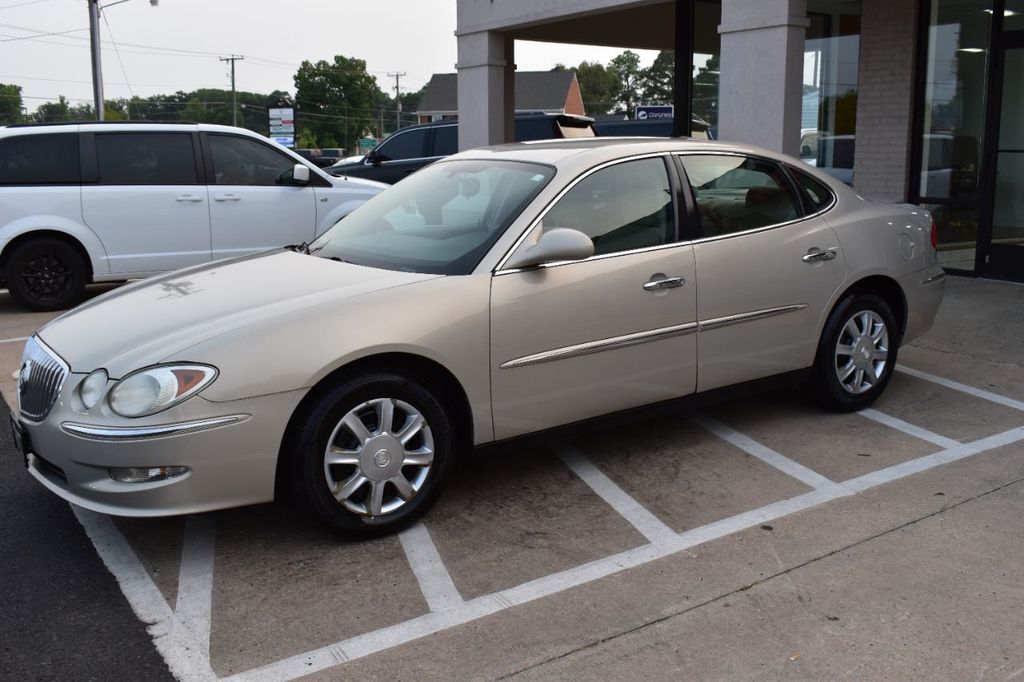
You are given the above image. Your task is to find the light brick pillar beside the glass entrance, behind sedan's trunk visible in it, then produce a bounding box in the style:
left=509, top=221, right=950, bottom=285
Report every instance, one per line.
left=853, top=0, right=918, bottom=202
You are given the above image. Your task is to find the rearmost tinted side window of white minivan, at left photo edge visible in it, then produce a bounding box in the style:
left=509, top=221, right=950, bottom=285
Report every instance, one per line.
left=0, top=133, right=82, bottom=184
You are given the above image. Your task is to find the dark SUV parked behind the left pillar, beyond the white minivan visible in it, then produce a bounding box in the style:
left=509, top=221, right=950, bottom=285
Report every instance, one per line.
left=328, top=114, right=596, bottom=184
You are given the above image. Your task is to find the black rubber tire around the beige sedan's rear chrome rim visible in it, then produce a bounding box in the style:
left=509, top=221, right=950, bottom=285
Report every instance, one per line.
left=807, top=294, right=900, bottom=412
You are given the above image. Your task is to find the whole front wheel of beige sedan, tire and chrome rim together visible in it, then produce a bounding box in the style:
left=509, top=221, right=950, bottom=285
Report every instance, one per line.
left=286, top=374, right=455, bottom=539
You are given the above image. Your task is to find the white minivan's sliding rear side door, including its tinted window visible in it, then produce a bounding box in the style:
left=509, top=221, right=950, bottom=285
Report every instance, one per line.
left=82, top=132, right=210, bottom=274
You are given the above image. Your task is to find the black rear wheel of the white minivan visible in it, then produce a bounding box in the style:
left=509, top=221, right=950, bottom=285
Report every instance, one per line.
left=4, top=237, right=89, bottom=311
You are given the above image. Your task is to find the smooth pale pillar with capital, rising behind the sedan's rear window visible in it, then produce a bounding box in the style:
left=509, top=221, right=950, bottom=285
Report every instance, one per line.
left=718, top=0, right=809, bottom=156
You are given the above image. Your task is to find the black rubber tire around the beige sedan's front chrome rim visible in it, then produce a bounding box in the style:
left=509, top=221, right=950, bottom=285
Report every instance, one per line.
left=282, top=373, right=457, bottom=540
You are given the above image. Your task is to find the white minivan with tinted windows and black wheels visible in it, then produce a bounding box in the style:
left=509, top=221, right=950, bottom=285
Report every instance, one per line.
left=0, top=122, right=388, bottom=310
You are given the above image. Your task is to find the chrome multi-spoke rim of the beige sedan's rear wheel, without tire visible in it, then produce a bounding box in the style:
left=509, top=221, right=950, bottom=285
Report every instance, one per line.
left=836, top=310, right=889, bottom=395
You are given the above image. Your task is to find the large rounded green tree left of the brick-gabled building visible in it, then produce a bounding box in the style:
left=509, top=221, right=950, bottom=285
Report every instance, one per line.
left=295, top=54, right=385, bottom=152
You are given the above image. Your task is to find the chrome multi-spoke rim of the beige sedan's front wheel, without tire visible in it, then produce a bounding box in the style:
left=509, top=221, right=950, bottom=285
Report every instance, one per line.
left=324, top=398, right=434, bottom=517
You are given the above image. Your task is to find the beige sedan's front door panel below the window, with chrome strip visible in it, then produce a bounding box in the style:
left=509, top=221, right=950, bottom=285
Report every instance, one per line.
left=490, top=245, right=696, bottom=438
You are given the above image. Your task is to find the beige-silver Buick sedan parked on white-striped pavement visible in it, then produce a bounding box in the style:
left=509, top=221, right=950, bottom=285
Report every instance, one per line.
left=14, top=138, right=943, bottom=537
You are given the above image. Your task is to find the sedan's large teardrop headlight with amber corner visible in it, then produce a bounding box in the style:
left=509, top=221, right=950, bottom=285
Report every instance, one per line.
left=110, top=365, right=217, bottom=417
